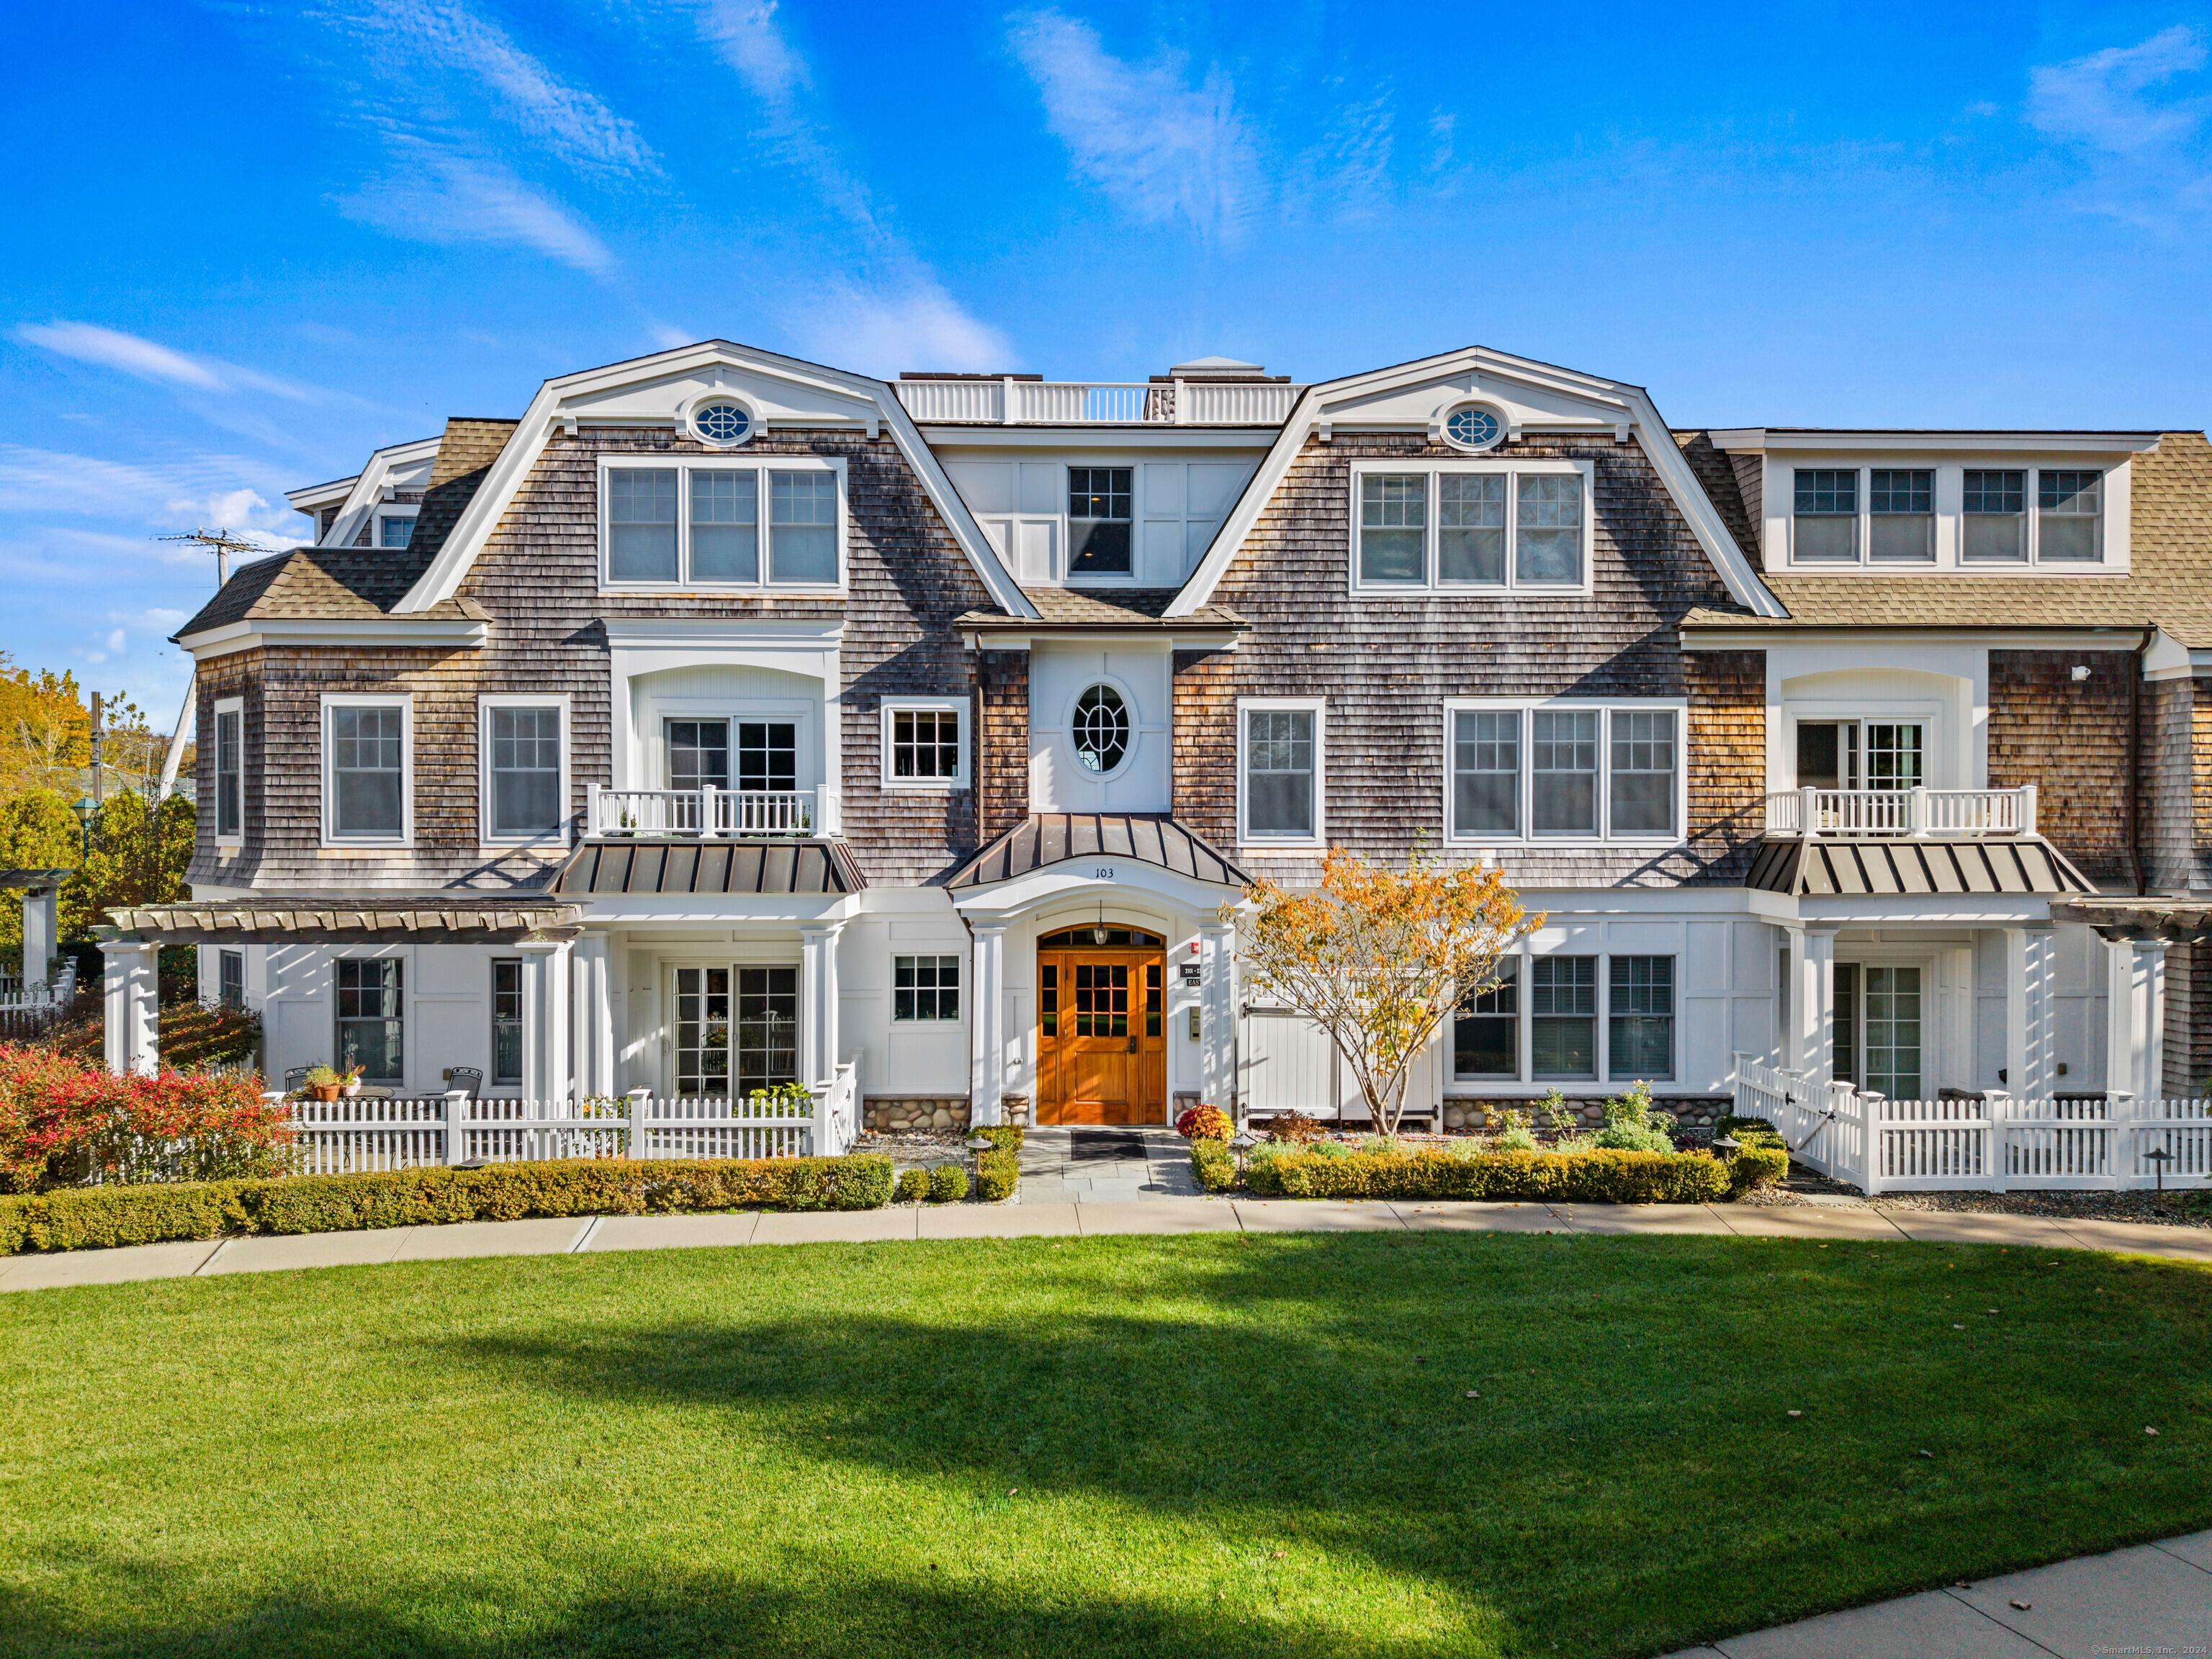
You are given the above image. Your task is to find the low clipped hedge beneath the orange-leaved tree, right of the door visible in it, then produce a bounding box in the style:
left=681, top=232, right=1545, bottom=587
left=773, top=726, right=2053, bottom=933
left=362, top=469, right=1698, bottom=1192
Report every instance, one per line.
left=1247, top=1150, right=1727, bottom=1203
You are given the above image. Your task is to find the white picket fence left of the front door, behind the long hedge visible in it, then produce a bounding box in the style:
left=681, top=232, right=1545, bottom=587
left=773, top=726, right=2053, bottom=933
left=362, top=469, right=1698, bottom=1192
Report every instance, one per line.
left=289, top=1055, right=860, bottom=1174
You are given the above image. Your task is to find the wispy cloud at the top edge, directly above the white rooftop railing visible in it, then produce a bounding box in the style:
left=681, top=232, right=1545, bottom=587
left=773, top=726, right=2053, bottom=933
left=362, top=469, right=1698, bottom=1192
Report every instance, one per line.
left=1009, top=11, right=1263, bottom=241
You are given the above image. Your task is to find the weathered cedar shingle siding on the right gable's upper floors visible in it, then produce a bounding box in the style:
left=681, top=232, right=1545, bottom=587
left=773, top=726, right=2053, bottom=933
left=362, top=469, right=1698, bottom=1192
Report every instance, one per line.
left=1174, top=433, right=1765, bottom=887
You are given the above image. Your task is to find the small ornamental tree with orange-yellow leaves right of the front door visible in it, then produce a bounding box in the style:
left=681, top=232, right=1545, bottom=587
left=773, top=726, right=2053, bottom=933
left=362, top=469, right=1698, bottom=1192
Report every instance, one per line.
left=1223, top=848, right=1544, bottom=1135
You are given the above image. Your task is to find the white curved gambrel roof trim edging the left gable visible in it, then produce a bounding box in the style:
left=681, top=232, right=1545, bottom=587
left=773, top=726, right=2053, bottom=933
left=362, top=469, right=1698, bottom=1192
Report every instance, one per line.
left=394, top=341, right=1038, bottom=617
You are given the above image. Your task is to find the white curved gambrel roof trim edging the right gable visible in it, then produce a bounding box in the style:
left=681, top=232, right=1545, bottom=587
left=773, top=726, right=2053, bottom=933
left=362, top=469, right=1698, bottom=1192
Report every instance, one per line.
left=1166, top=347, right=1789, bottom=619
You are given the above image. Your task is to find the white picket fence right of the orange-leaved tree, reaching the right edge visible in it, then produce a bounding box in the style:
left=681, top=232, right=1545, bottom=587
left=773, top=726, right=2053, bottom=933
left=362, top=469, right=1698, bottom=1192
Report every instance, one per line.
left=1737, top=1055, right=2212, bottom=1195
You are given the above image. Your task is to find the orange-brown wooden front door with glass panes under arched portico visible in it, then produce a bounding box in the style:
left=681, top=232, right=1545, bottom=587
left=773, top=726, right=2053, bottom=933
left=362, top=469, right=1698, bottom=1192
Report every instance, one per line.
left=1038, top=927, right=1168, bottom=1124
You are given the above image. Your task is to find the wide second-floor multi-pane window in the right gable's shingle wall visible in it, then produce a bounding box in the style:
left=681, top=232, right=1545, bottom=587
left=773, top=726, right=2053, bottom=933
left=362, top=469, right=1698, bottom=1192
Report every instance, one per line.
left=1444, top=701, right=1683, bottom=845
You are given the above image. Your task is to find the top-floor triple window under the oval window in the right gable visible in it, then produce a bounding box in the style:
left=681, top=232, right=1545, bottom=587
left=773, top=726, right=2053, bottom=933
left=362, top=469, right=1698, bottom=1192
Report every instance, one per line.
left=1352, top=460, right=1593, bottom=593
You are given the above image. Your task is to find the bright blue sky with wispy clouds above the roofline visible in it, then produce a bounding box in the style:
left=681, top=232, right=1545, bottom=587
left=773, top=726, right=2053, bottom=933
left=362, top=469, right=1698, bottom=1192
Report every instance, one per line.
left=0, top=0, right=2212, bottom=724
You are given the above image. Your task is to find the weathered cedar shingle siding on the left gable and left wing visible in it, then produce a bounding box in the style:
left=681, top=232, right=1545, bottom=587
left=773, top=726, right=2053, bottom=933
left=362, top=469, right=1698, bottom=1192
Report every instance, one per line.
left=192, top=423, right=991, bottom=889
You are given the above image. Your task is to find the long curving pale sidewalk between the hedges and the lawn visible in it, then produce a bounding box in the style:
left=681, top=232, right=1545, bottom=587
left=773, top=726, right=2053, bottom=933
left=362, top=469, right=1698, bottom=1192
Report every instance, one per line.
left=0, top=1185, right=2212, bottom=1292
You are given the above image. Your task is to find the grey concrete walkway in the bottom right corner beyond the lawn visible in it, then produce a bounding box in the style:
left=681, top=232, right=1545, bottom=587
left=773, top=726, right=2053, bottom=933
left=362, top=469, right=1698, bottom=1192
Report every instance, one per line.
left=1672, top=1533, right=2212, bottom=1659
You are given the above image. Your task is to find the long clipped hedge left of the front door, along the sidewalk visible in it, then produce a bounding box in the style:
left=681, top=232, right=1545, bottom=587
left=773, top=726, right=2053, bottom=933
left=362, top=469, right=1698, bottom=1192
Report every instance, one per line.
left=0, top=1155, right=898, bottom=1254
